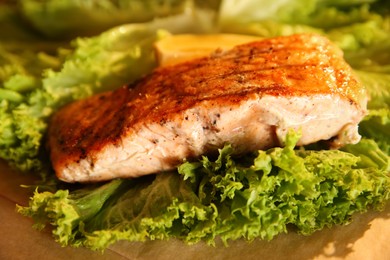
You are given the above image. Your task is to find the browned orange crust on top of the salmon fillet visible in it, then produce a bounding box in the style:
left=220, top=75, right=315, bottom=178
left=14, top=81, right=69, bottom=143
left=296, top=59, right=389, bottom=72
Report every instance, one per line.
left=49, top=34, right=364, bottom=182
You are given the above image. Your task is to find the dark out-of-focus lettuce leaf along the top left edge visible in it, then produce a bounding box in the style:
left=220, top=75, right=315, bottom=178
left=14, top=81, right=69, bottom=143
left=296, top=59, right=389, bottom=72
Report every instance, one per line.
left=19, top=0, right=186, bottom=39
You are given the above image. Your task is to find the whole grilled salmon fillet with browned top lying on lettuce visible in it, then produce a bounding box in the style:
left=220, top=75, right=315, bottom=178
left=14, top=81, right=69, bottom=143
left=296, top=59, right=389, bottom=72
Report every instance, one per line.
left=48, top=34, right=367, bottom=182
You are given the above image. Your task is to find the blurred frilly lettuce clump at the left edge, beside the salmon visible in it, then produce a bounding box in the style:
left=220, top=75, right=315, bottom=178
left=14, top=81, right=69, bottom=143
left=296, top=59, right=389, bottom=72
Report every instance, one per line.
left=0, top=43, right=62, bottom=171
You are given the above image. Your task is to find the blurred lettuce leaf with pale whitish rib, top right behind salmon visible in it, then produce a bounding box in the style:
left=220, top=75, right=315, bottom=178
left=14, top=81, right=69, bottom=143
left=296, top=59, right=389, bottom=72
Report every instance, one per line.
left=218, top=0, right=390, bottom=73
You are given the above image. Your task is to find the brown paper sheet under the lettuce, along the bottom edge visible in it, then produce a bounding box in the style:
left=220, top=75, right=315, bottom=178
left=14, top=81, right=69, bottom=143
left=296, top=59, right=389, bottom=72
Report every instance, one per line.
left=0, top=161, right=390, bottom=260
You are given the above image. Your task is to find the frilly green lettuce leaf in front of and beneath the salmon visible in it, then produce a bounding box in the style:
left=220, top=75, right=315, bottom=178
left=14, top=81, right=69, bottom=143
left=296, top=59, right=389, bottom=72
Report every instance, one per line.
left=18, top=133, right=390, bottom=250
